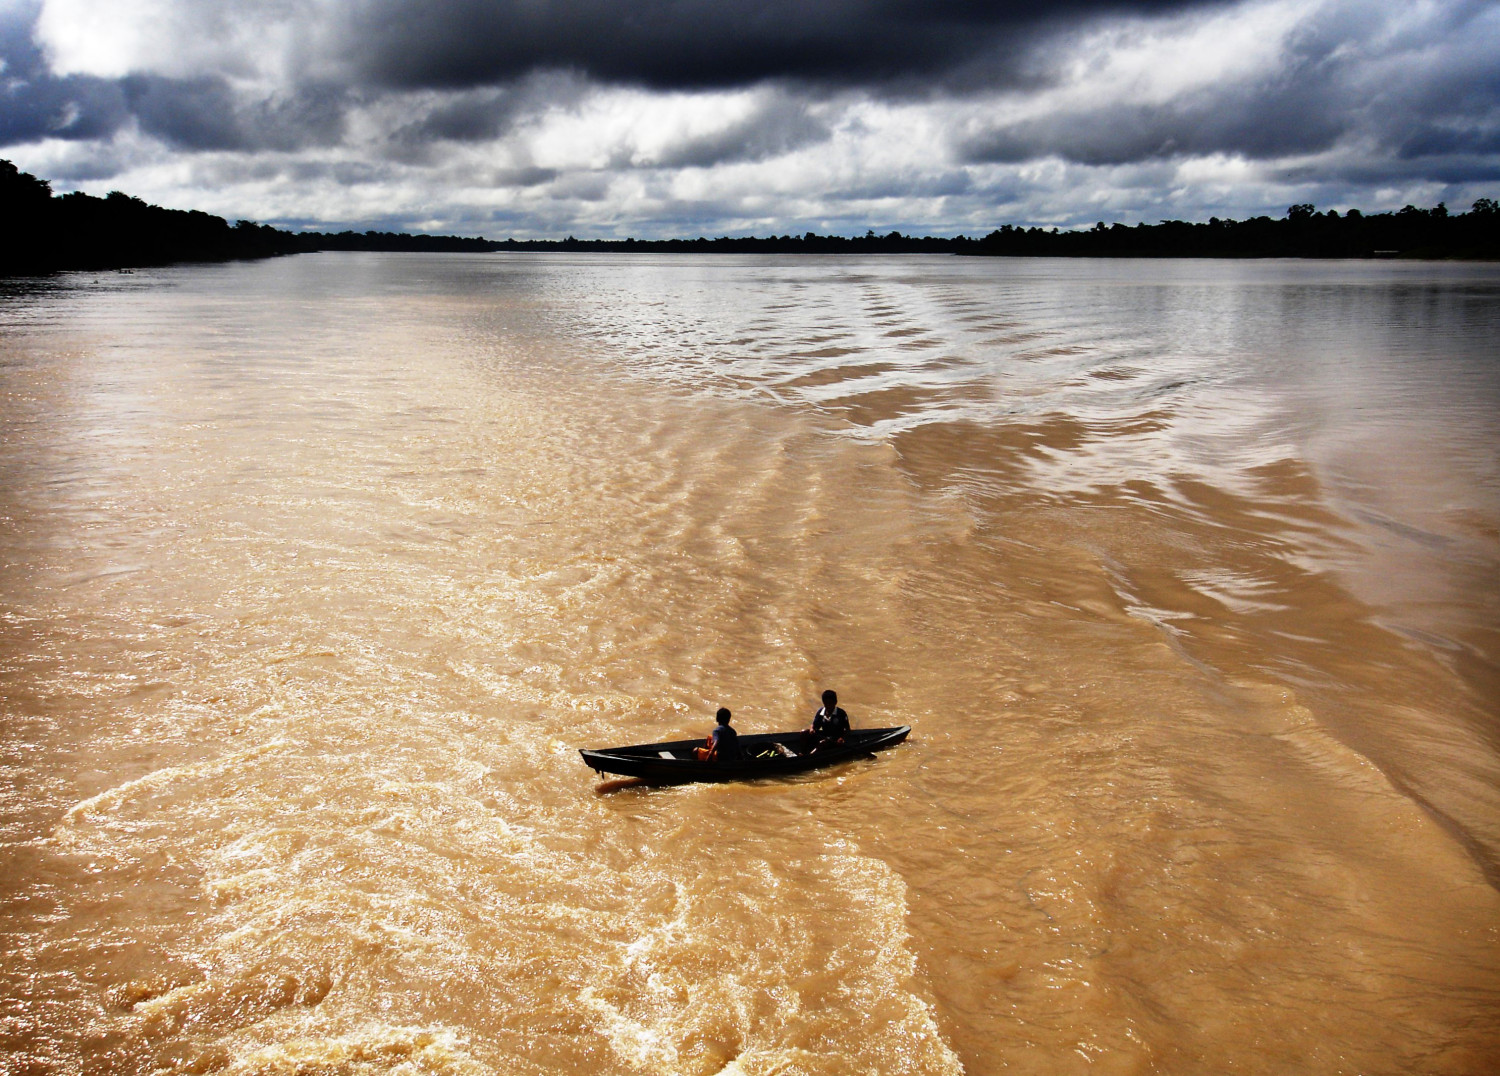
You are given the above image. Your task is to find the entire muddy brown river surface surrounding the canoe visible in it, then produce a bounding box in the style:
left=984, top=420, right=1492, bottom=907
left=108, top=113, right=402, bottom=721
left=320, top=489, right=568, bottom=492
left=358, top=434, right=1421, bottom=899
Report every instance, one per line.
left=0, top=254, right=1500, bottom=1076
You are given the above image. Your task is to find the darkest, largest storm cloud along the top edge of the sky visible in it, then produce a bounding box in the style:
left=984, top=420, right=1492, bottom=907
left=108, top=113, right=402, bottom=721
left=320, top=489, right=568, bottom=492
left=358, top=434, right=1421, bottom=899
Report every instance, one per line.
left=344, top=0, right=1218, bottom=89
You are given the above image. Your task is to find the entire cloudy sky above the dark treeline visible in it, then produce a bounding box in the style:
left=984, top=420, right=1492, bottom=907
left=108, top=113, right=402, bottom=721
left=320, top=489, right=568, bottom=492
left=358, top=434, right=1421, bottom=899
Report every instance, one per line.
left=0, top=0, right=1500, bottom=239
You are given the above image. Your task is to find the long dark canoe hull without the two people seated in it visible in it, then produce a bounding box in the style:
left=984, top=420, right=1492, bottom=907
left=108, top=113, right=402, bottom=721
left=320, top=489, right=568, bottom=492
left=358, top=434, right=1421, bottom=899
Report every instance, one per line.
left=579, top=725, right=912, bottom=785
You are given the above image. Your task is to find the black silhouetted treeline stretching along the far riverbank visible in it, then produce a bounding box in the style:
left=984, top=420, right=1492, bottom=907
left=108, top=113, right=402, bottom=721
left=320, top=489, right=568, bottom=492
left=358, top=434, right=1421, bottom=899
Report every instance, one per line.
left=0, top=161, right=1500, bottom=276
